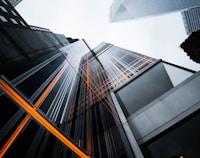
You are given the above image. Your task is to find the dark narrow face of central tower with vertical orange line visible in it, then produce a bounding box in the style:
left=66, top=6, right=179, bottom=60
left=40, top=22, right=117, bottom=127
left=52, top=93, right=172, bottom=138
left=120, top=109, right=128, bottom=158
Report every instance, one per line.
left=64, top=46, right=138, bottom=157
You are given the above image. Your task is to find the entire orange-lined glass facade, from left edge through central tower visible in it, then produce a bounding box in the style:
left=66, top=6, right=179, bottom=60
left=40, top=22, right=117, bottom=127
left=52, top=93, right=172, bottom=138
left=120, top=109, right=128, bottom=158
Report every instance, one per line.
left=0, top=35, right=157, bottom=157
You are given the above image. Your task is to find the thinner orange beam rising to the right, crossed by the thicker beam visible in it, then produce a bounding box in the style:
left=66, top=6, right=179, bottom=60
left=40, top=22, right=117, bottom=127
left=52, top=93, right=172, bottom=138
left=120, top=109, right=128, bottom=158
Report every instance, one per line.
left=0, top=64, right=68, bottom=157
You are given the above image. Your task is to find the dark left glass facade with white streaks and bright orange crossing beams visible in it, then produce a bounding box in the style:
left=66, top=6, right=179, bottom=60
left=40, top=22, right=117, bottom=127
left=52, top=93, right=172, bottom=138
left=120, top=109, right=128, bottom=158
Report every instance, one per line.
left=0, top=41, right=91, bottom=157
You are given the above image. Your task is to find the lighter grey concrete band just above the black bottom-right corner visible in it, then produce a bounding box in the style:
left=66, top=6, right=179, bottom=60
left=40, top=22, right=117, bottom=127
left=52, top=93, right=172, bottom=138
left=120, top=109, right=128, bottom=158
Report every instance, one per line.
left=127, top=72, right=200, bottom=144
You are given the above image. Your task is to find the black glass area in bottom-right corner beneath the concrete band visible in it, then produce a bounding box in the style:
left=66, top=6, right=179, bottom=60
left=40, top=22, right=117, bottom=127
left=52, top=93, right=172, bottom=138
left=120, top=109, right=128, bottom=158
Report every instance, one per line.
left=141, top=111, right=200, bottom=158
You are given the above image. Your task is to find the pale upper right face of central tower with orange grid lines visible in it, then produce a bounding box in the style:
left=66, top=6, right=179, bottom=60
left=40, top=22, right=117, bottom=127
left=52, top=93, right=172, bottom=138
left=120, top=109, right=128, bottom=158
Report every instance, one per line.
left=98, top=47, right=157, bottom=91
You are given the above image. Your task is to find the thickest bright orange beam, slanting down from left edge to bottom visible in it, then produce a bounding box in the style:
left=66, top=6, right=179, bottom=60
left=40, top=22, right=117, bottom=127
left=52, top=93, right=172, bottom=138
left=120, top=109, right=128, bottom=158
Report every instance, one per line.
left=0, top=79, right=90, bottom=158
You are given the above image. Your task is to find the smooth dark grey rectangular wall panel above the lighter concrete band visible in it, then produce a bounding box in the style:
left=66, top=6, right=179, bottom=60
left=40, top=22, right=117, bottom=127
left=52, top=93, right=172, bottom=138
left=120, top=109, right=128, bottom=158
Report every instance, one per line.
left=116, top=62, right=173, bottom=116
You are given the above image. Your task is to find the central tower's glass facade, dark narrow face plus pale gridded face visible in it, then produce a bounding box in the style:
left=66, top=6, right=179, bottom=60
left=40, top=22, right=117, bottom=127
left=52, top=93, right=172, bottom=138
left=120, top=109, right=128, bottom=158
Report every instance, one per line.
left=65, top=44, right=156, bottom=157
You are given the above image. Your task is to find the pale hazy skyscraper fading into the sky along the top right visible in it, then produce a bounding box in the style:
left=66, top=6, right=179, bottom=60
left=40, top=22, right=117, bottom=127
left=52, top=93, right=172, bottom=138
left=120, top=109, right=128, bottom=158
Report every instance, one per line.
left=110, top=0, right=200, bottom=22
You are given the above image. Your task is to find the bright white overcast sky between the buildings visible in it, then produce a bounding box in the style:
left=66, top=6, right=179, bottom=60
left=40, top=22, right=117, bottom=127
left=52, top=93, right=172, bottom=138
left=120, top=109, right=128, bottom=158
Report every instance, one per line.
left=16, top=0, right=200, bottom=71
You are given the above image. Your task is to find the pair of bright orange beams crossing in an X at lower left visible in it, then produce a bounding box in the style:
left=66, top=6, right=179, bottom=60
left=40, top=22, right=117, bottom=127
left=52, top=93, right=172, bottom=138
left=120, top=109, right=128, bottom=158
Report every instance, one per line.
left=0, top=66, right=88, bottom=157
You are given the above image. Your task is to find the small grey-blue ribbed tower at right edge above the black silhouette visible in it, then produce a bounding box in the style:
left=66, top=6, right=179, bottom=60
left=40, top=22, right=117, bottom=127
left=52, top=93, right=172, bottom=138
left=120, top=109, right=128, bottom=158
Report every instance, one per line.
left=181, top=7, right=200, bottom=35
